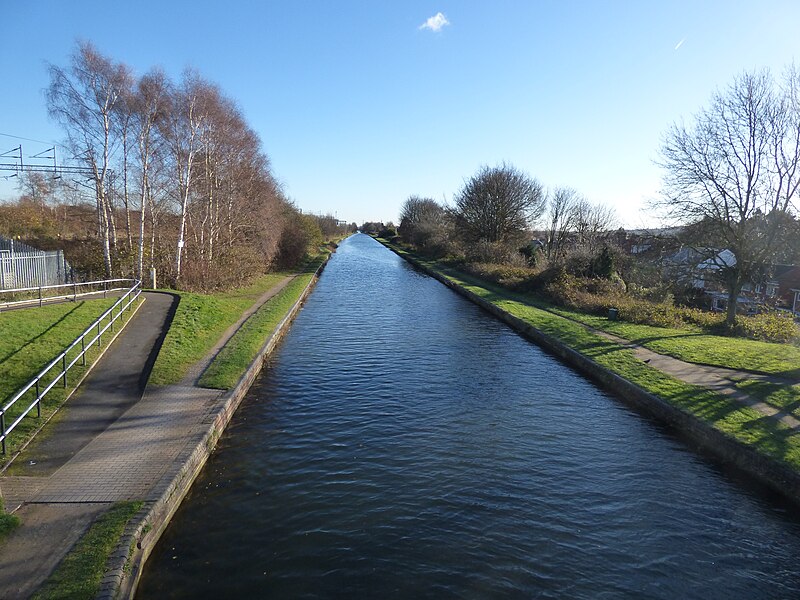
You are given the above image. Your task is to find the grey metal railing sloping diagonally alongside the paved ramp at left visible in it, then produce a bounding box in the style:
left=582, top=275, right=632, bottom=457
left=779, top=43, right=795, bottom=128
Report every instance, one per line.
left=0, top=280, right=142, bottom=454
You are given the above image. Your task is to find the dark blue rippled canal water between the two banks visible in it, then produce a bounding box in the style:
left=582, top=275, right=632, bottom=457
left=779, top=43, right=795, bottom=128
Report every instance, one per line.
left=138, top=234, right=800, bottom=600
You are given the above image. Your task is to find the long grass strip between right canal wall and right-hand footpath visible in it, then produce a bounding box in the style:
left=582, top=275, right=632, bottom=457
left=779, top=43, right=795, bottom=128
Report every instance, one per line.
left=384, top=241, right=800, bottom=469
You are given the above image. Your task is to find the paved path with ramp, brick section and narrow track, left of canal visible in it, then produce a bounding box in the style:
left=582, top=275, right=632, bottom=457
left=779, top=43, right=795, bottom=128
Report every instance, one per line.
left=0, top=277, right=292, bottom=600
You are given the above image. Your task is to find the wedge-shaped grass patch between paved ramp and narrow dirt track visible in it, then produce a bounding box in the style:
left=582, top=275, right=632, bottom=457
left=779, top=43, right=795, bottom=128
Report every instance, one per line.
left=149, top=273, right=288, bottom=385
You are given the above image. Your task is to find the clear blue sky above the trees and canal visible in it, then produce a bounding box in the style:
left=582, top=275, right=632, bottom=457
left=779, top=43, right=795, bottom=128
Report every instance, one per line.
left=0, top=0, right=800, bottom=227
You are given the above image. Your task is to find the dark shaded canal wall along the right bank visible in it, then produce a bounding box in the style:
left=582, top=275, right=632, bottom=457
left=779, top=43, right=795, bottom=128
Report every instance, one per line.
left=377, top=240, right=800, bottom=503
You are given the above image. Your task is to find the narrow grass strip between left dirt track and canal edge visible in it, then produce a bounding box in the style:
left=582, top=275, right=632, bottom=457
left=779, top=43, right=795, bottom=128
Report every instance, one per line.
left=200, top=258, right=322, bottom=390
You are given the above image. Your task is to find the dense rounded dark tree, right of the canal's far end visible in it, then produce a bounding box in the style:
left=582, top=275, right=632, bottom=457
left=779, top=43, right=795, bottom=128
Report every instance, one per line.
left=455, top=164, right=545, bottom=245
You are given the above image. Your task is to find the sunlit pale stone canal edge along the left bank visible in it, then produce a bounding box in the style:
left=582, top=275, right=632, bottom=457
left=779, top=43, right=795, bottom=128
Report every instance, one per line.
left=101, top=255, right=335, bottom=600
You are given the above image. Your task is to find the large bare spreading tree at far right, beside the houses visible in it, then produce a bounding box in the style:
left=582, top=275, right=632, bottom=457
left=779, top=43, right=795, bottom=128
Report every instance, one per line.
left=661, top=68, right=800, bottom=326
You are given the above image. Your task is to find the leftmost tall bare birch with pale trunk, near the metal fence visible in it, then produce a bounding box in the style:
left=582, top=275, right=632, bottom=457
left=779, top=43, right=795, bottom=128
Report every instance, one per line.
left=47, top=42, right=130, bottom=277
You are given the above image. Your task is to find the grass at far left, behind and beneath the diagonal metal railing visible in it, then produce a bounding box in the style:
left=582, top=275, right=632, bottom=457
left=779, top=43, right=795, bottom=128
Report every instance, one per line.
left=0, top=298, right=137, bottom=464
